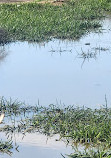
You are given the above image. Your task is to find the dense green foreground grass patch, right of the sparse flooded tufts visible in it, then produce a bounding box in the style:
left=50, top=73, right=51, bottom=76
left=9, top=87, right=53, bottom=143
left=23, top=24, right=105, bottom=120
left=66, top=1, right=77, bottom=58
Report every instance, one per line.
left=25, top=107, right=111, bottom=146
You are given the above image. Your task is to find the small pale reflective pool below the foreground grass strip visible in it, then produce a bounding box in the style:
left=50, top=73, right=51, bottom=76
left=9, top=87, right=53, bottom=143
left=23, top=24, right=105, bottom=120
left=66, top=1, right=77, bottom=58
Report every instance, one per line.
left=0, top=133, right=72, bottom=158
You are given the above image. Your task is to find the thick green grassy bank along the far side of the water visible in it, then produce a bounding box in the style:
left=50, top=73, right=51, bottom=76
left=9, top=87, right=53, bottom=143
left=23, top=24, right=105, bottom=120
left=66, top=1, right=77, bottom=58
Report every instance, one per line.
left=0, top=0, right=111, bottom=42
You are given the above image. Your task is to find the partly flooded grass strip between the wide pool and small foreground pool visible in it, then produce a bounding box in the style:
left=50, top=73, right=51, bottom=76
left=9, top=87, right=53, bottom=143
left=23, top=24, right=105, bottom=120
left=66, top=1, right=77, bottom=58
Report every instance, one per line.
left=0, top=101, right=111, bottom=146
